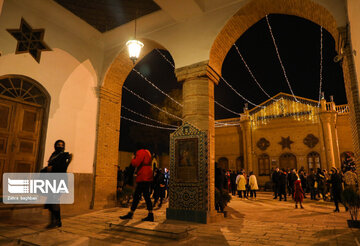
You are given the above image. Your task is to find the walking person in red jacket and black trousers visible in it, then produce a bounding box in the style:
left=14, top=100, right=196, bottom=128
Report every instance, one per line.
left=120, top=144, right=154, bottom=221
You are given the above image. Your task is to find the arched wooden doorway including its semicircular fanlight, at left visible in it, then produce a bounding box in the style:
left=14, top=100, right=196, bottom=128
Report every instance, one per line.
left=0, top=75, right=50, bottom=184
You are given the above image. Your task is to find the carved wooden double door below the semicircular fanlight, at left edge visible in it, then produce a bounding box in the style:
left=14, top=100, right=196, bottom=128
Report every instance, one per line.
left=0, top=98, right=43, bottom=185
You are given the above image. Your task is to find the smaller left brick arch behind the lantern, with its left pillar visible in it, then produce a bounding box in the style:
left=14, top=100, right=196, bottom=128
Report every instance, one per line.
left=90, top=39, right=171, bottom=208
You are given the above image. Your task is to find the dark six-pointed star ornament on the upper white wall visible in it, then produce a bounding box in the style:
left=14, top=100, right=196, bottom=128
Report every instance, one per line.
left=6, top=18, right=51, bottom=63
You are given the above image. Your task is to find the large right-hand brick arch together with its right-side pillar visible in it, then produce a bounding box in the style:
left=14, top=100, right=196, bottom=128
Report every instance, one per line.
left=208, top=0, right=360, bottom=175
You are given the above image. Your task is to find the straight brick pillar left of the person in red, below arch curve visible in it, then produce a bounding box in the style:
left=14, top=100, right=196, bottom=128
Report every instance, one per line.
left=89, top=87, right=121, bottom=209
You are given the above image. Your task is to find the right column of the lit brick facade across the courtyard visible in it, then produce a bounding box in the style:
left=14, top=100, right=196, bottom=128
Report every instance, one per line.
left=319, top=99, right=340, bottom=170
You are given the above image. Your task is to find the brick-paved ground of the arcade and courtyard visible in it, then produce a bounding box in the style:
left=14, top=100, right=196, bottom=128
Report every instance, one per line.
left=0, top=192, right=360, bottom=246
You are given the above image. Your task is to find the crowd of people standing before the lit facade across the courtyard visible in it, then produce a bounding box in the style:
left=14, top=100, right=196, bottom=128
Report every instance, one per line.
left=215, top=153, right=358, bottom=212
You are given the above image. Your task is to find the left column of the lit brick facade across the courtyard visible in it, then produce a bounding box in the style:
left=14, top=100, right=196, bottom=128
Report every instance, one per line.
left=240, top=110, right=254, bottom=172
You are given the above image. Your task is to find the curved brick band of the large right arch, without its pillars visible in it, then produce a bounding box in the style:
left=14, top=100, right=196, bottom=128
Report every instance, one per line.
left=209, top=0, right=339, bottom=78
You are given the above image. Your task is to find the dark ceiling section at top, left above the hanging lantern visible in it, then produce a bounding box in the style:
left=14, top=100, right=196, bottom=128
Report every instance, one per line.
left=54, top=0, right=160, bottom=32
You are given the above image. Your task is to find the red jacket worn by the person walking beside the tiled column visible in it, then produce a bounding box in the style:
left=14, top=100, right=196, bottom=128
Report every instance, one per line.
left=131, top=149, right=153, bottom=183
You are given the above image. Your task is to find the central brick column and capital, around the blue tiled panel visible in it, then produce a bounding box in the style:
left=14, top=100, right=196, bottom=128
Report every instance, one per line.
left=176, top=61, right=216, bottom=217
